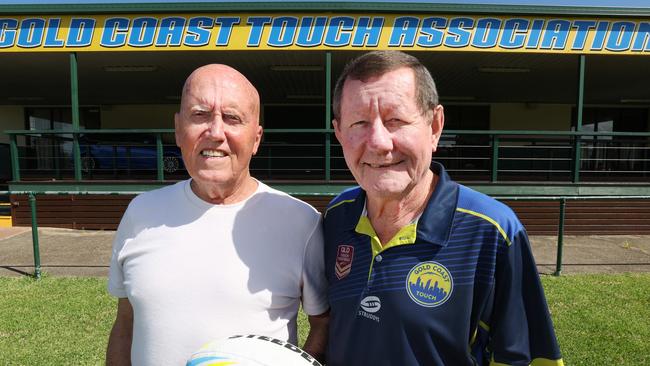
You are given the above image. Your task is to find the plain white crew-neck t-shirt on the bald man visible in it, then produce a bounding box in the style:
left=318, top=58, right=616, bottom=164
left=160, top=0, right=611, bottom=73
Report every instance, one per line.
left=108, top=180, right=328, bottom=365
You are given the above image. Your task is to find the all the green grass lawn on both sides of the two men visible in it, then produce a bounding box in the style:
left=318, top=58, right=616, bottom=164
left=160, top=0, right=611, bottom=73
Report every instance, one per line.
left=0, top=274, right=650, bottom=366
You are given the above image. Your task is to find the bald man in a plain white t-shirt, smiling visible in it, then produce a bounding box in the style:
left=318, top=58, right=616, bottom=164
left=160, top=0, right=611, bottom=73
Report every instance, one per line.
left=106, top=65, right=328, bottom=365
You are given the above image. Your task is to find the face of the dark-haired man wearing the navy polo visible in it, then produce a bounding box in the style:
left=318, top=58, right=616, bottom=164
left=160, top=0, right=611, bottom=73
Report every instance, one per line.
left=334, top=68, right=444, bottom=202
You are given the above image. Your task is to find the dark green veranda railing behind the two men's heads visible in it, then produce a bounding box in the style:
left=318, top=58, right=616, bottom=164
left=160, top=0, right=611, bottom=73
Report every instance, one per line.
left=6, top=129, right=650, bottom=183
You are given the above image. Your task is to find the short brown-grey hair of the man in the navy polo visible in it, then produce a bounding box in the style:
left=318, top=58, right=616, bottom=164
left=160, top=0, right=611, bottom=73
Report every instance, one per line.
left=332, top=51, right=438, bottom=120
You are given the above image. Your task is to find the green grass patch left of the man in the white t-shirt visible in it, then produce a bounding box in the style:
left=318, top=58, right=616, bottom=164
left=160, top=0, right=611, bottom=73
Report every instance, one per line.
left=0, top=276, right=116, bottom=365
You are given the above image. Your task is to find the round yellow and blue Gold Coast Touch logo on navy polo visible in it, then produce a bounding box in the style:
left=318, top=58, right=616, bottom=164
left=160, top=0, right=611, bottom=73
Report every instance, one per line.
left=406, top=261, right=454, bottom=308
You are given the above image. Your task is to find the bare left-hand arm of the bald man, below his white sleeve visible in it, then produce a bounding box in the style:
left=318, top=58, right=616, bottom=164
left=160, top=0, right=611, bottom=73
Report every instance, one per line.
left=106, top=298, right=133, bottom=366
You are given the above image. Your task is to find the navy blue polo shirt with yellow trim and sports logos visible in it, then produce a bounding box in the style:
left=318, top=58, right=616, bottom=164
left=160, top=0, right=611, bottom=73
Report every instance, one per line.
left=324, top=163, right=563, bottom=366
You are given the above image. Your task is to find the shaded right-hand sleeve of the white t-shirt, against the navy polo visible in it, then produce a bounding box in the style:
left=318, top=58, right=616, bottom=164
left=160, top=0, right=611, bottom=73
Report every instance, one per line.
left=302, top=219, right=329, bottom=315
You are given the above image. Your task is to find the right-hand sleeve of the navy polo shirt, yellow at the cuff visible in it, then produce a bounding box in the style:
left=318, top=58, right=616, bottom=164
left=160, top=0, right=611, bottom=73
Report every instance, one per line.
left=489, top=228, right=563, bottom=366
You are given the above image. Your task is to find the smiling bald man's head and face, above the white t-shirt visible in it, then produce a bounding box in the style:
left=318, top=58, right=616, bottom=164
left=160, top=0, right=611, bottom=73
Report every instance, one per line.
left=174, top=65, right=262, bottom=192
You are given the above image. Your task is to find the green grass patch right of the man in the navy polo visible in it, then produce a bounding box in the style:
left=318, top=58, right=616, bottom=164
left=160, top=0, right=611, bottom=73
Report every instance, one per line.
left=542, top=273, right=650, bottom=366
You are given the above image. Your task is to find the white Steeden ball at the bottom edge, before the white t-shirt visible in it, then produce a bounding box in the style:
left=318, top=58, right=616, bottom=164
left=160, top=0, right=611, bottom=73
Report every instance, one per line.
left=186, top=335, right=322, bottom=366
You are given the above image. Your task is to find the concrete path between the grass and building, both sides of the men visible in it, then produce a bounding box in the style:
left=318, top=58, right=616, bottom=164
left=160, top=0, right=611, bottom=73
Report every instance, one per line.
left=0, top=227, right=650, bottom=276
